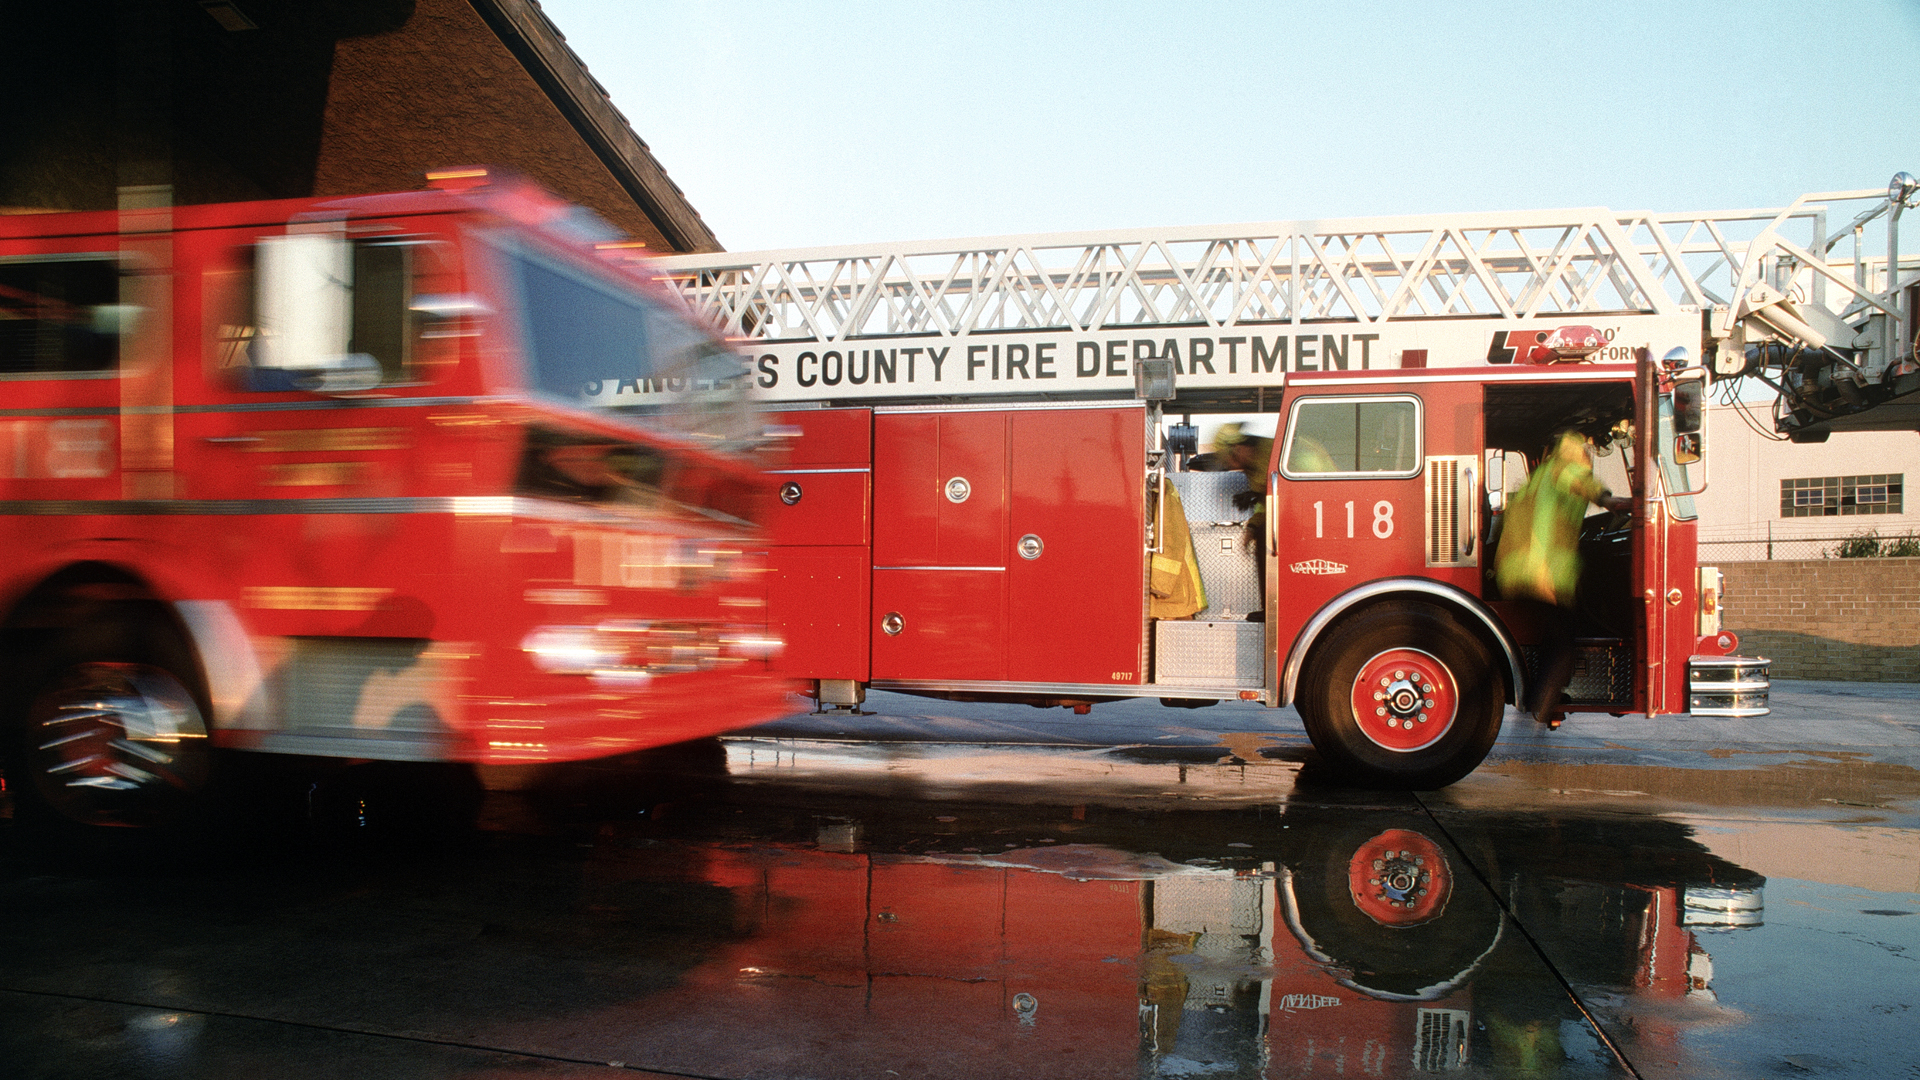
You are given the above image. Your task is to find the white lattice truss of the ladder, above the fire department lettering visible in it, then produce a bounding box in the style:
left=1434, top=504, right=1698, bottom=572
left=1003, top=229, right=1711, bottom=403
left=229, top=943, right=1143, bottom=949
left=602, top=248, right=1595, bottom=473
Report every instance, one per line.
left=653, top=188, right=1897, bottom=344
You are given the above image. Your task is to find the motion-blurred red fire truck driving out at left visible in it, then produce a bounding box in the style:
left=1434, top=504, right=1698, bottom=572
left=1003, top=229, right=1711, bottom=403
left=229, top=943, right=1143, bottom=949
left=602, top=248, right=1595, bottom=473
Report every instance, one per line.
left=0, top=169, right=789, bottom=824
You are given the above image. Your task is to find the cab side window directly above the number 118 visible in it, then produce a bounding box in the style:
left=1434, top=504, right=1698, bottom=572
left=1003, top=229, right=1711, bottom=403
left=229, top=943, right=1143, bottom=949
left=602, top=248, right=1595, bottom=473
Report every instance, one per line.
left=1281, top=394, right=1421, bottom=480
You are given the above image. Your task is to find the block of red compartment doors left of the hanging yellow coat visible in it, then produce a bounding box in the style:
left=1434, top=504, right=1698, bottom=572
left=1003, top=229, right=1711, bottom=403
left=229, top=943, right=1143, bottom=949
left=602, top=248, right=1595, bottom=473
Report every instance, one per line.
left=874, top=407, right=1146, bottom=686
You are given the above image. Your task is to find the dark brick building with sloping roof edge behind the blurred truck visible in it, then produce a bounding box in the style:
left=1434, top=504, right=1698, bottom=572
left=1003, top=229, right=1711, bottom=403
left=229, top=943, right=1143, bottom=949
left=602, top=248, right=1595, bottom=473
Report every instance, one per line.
left=0, top=0, right=720, bottom=254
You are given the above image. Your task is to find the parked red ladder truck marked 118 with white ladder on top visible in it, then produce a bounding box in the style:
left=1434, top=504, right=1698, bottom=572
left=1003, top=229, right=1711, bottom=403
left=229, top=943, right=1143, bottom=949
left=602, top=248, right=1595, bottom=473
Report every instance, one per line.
left=660, top=209, right=1804, bottom=788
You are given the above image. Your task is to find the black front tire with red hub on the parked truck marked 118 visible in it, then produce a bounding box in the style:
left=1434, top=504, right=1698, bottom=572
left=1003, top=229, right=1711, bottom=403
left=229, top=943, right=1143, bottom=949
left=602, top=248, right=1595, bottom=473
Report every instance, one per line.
left=1296, top=603, right=1505, bottom=792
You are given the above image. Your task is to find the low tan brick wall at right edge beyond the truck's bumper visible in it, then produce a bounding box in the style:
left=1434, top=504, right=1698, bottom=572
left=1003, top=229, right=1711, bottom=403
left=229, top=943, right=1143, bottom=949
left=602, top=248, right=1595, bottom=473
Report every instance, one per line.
left=1720, top=559, right=1920, bottom=682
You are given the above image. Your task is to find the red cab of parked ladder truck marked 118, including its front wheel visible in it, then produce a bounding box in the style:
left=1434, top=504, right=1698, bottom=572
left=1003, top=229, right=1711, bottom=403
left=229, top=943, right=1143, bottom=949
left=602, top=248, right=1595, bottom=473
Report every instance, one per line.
left=1267, top=353, right=1697, bottom=784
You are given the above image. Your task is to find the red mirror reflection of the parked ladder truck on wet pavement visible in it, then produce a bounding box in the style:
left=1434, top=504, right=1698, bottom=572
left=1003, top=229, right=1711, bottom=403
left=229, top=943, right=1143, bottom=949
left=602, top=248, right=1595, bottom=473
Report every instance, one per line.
left=533, top=760, right=1761, bottom=1076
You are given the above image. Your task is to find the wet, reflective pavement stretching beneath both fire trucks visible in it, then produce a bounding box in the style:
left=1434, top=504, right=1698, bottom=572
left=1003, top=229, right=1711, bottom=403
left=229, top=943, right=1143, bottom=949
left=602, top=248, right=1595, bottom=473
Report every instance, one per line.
left=0, top=682, right=1920, bottom=1080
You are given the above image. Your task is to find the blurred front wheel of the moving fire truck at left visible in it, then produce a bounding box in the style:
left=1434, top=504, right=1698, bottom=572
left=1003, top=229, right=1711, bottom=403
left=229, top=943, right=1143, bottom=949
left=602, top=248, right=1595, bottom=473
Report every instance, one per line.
left=6, top=613, right=213, bottom=836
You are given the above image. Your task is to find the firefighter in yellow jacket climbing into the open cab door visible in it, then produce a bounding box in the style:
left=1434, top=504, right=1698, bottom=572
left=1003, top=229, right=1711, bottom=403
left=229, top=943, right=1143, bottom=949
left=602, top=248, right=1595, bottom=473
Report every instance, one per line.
left=1494, top=430, right=1632, bottom=726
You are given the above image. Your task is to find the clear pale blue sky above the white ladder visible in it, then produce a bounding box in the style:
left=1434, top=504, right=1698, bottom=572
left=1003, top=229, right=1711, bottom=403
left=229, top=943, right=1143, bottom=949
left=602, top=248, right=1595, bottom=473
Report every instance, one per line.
left=543, top=0, right=1920, bottom=252
